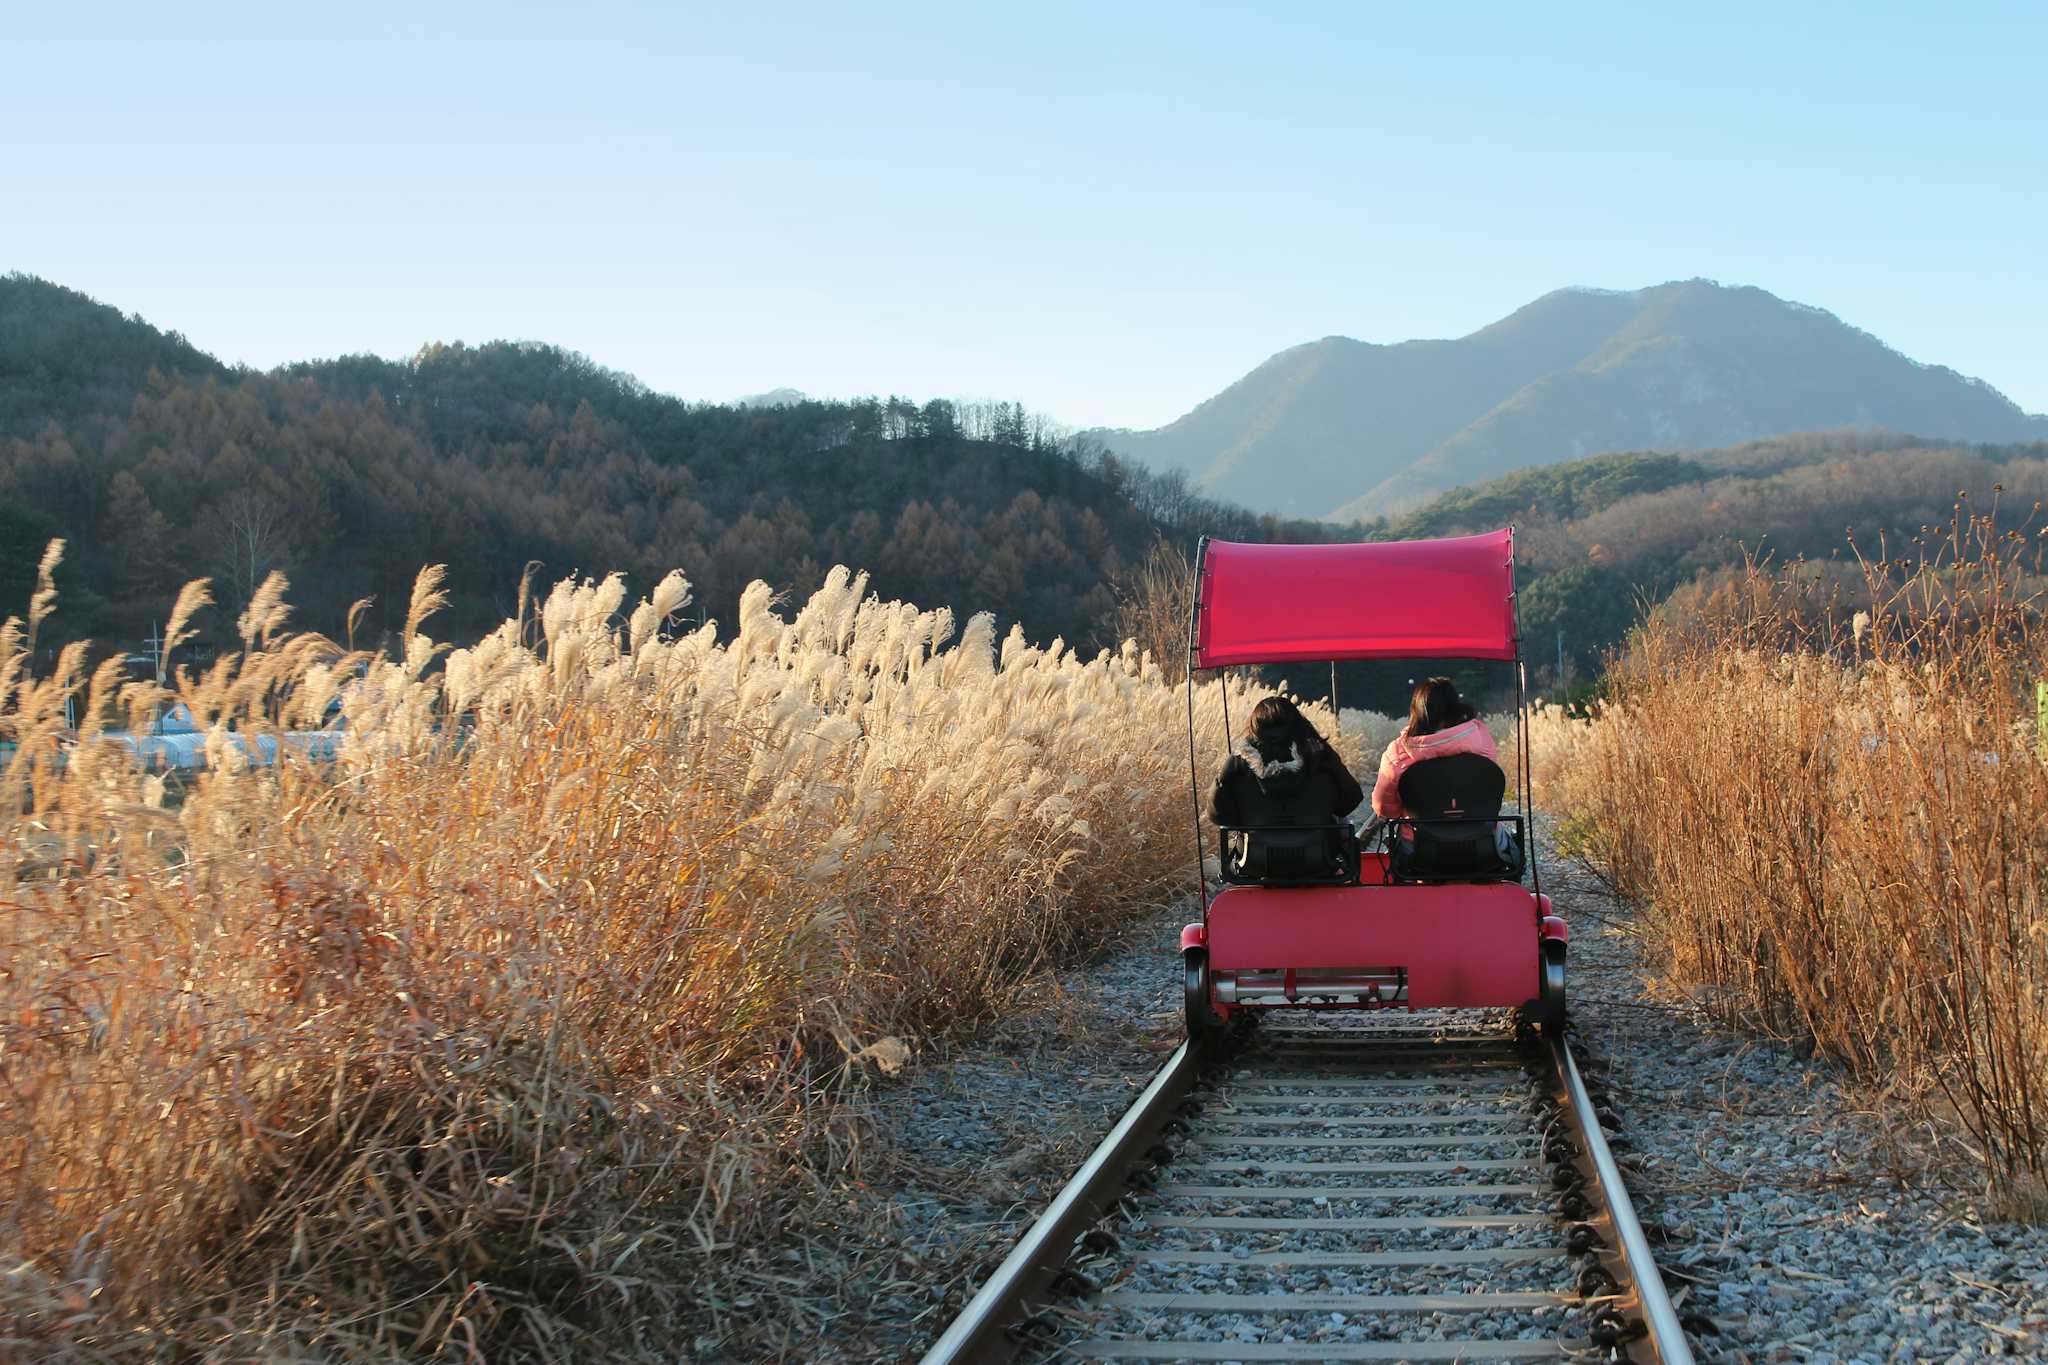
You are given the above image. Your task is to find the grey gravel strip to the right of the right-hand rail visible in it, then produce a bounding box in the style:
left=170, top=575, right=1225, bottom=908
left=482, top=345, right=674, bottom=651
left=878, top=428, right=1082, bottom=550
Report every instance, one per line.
left=1544, top=847, right=2048, bottom=1365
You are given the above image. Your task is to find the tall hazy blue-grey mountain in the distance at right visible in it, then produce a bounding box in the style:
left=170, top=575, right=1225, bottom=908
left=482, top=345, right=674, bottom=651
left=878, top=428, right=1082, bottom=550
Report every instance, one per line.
left=1092, top=280, right=2048, bottom=520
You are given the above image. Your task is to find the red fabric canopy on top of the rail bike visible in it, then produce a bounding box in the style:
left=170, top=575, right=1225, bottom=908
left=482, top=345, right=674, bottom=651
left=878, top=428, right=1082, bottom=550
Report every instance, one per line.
left=1196, top=530, right=1516, bottom=669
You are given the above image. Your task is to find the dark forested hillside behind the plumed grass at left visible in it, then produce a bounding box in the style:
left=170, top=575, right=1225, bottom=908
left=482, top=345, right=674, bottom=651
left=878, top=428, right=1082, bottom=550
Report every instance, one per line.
left=0, top=276, right=1315, bottom=643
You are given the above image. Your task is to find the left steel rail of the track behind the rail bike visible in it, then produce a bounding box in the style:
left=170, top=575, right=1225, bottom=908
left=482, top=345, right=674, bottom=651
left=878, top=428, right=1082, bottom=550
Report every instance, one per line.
left=922, top=1044, right=1202, bottom=1365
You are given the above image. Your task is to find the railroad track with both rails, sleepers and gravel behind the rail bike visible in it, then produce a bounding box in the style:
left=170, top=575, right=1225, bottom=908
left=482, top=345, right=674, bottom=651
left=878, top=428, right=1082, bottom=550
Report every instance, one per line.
left=924, top=1011, right=1692, bottom=1365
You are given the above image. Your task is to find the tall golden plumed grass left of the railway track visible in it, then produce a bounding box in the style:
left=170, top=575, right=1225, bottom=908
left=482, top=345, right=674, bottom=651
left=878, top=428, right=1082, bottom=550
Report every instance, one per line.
left=0, top=565, right=1333, bottom=1359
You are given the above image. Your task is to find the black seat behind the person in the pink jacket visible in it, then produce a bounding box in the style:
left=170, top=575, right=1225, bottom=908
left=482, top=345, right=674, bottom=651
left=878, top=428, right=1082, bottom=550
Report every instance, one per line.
left=1386, top=753, right=1526, bottom=882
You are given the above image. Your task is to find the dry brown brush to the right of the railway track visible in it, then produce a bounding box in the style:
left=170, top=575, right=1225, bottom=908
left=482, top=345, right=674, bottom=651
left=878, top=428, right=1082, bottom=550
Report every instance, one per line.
left=1565, top=505, right=2048, bottom=1207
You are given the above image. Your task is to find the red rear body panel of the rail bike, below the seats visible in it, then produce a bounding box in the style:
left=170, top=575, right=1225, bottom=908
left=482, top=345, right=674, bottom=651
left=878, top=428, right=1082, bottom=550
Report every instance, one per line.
left=1208, top=882, right=1540, bottom=1009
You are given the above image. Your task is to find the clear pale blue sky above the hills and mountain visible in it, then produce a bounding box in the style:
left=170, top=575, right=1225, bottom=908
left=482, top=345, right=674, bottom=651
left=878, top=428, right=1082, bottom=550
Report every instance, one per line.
left=0, top=2, right=2048, bottom=426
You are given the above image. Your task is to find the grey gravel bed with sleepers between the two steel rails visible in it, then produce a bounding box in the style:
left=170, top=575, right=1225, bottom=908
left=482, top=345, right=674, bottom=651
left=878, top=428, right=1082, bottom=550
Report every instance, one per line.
left=1047, top=1011, right=1583, bottom=1359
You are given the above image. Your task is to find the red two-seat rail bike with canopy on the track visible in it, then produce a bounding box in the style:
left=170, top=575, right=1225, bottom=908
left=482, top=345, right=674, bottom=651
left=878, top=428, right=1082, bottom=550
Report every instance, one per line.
left=1182, top=530, right=1567, bottom=1046
